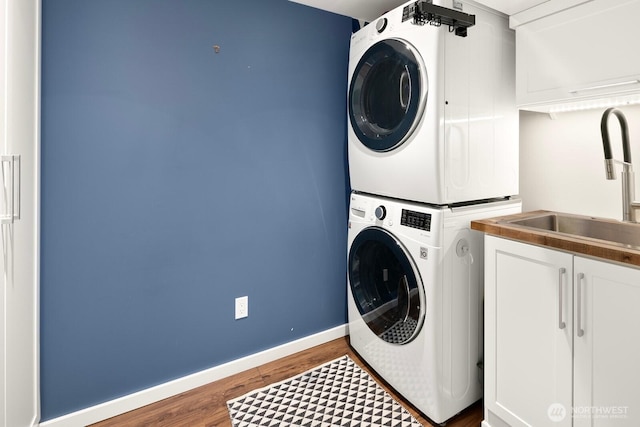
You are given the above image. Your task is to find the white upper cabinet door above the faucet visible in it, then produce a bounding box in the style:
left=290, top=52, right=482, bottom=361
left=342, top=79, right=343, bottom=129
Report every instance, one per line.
left=516, top=0, right=640, bottom=111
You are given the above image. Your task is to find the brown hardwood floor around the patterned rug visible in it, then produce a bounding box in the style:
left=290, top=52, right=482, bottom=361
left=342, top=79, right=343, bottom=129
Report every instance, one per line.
left=92, top=337, right=482, bottom=427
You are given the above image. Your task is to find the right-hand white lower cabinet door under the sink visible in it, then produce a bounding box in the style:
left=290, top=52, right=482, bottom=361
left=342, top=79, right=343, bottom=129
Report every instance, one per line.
left=573, top=257, right=640, bottom=427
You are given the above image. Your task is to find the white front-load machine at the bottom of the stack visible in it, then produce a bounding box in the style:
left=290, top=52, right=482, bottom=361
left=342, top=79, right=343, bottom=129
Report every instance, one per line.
left=347, top=193, right=521, bottom=423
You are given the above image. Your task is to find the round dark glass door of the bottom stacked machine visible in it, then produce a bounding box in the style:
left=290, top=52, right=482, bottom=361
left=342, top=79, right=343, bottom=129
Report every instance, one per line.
left=349, top=227, right=425, bottom=344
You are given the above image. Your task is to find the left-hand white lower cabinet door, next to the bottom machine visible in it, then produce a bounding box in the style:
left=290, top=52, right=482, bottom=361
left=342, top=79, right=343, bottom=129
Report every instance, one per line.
left=484, top=236, right=573, bottom=427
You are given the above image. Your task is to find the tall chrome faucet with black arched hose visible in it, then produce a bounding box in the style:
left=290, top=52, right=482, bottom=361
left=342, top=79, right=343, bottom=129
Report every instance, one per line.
left=600, top=108, right=640, bottom=222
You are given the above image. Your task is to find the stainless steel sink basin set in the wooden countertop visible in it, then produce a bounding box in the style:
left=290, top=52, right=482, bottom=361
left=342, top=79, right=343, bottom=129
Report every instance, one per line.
left=507, top=213, right=640, bottom=248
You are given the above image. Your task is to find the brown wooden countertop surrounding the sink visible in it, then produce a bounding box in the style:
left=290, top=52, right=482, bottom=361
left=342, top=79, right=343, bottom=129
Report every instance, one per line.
left=471, top=210, right=640, bottom=267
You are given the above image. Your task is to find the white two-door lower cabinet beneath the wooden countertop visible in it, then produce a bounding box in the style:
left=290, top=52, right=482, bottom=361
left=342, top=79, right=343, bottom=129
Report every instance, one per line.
left=483, top=236, right=640, bottom=427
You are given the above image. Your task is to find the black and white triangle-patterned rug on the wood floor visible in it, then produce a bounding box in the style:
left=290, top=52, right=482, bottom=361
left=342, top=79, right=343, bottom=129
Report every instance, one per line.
left=227, top=356, right=422, bottom=427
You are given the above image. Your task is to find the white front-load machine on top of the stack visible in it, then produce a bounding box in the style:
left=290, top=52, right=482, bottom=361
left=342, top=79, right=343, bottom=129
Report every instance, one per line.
left=348, top=0, right=518, bottom=205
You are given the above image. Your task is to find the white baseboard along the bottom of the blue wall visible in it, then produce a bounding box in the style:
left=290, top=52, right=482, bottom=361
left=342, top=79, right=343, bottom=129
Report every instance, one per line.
left=40, top=324, right=347, bottom=427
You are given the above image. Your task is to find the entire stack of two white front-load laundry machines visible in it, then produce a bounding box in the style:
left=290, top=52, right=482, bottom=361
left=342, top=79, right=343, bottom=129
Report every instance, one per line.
left=347, top=0, right=521, bottom=423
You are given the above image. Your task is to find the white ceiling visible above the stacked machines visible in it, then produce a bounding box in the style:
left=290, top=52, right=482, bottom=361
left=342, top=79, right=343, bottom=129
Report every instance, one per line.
left=291, top=0, right=551, bottom=22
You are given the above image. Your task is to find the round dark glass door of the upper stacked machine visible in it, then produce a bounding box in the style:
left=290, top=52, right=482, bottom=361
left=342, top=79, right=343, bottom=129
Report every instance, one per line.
left=349, top=39, right=427, bottom=151
